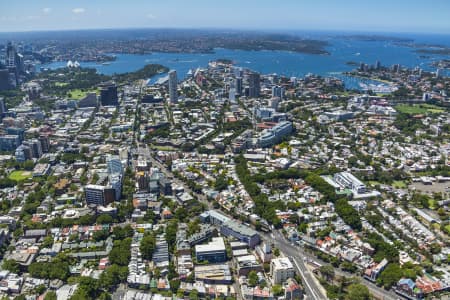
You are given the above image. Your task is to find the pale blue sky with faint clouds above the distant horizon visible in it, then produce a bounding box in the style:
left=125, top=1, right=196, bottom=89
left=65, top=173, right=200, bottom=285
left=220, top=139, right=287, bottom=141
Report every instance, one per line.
left=0, top=0, right=450, bottom=33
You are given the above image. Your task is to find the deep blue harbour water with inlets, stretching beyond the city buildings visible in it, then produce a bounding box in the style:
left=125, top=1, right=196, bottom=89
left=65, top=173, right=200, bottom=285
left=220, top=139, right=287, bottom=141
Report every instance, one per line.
left=38, top=32, right=450, bottom=89
